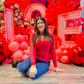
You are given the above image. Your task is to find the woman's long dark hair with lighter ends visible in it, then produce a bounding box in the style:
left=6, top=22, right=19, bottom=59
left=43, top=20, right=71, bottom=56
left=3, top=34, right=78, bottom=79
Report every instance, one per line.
left=34, top=16, right=52, bottom=43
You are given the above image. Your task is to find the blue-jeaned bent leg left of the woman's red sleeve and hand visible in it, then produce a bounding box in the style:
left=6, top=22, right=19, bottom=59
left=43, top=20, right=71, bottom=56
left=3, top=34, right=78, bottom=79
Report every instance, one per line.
left=17, top=56, right=31, bottom=73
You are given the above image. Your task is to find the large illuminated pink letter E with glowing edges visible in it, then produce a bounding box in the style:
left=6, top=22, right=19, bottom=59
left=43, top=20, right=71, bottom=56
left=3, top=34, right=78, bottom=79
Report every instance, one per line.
left=58, top=10, right=83, bottom=47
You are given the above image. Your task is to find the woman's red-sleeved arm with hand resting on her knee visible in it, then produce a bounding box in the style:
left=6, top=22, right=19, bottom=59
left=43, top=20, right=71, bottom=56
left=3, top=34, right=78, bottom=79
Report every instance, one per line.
left=29, top=34, right=37, bottom=78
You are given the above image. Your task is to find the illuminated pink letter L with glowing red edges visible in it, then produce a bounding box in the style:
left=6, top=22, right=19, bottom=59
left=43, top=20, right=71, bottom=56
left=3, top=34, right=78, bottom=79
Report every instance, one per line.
left=4, top=9, right=14, bottom=41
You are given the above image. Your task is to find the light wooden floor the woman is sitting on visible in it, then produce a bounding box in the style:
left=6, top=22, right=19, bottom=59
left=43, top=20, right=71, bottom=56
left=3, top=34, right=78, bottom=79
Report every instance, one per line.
left=0, top=61, right=84, bottom=84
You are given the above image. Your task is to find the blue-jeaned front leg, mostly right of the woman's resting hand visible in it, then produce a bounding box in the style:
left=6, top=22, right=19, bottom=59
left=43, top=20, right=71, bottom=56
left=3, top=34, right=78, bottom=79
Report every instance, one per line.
left=27, top=62, right=50, bottom=79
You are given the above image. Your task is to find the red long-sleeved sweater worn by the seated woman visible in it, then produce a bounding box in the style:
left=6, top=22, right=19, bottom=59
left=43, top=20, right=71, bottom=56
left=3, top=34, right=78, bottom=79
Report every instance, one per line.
left=30, top=33, right=57, bottom=67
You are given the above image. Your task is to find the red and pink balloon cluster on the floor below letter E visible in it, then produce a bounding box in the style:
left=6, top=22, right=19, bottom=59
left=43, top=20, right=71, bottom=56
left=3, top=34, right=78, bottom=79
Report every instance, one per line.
left=56, top=31, right=84, bottom=65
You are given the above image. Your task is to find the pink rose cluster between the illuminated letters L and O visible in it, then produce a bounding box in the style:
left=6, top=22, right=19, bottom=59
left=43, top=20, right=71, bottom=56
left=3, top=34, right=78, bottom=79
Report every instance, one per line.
left=10, top=4, right=35, bottom=27
